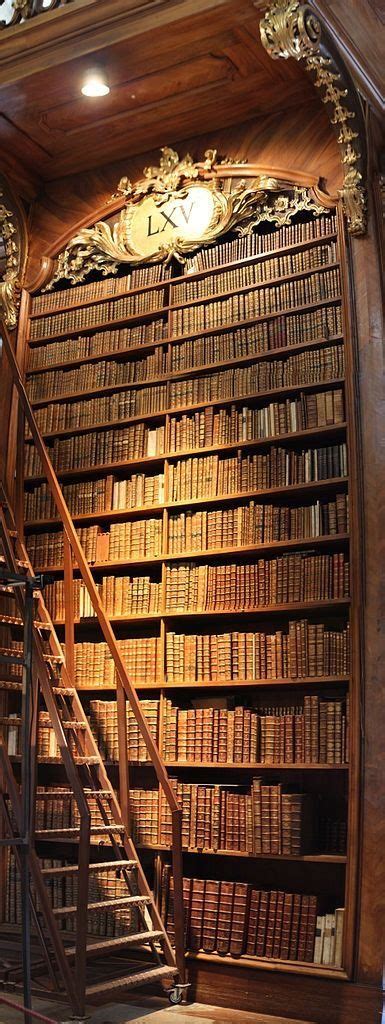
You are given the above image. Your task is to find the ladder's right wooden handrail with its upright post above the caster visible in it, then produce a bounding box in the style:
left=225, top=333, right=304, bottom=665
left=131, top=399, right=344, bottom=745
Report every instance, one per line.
left=0, top=321, right=184, bottom=980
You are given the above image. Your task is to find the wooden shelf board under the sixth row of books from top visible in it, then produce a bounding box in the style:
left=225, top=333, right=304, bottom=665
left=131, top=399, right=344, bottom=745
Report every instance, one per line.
left=25, top=422, right=346, bottom=483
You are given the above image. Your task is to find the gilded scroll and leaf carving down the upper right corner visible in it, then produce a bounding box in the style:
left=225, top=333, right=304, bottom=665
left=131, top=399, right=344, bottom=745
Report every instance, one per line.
left=260, top=0, right=367, bottom=234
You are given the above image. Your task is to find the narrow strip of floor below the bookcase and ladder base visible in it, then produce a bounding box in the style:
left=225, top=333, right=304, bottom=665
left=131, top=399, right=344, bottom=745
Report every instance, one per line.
left=0, top=993, right=312, bottom=1024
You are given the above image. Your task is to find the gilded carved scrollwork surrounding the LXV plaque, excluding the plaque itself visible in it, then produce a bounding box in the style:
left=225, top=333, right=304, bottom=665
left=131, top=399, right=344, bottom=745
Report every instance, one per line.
left=30, top=153, right=339, bottom=291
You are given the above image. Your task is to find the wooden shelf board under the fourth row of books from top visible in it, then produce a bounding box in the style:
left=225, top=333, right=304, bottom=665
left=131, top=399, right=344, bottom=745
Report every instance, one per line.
left=31, top=335, right=342, bottom=409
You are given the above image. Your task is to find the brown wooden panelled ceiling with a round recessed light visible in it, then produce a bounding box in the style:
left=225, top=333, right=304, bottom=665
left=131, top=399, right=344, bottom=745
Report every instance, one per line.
left=0, top=0, right=314, bottom=198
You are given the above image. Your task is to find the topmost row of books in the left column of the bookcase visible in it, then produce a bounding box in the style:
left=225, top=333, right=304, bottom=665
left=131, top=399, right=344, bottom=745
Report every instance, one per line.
left=31, top=263, right=167, bottom=316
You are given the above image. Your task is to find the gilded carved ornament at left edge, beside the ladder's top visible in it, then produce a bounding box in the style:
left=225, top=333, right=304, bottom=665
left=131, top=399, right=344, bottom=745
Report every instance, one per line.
left=0, top=174, right=28, bottom=330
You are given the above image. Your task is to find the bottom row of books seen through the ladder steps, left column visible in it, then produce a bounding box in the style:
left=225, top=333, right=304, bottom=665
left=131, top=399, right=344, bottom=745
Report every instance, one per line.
left=5, top=854, right=142, bottom=938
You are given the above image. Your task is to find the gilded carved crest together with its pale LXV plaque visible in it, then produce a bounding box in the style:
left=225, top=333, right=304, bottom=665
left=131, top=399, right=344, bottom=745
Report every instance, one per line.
left=46, top=147, right=326, bottom=290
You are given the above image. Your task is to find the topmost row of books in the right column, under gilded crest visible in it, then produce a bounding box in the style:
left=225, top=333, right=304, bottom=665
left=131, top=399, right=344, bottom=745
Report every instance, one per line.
left=184, top=213, right=337, bottom=273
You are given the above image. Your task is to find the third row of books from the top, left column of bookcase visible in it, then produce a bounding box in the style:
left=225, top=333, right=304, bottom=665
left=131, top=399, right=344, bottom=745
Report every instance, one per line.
left=28, top=317, right=167, bottom=374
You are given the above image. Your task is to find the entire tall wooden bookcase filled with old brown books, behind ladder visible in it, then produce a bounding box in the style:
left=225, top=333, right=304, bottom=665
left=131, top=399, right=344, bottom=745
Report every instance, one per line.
left=2, top=190, right=357, bottom=978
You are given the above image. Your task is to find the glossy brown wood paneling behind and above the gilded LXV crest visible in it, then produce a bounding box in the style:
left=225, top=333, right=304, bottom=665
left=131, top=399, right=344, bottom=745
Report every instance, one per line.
left=26, top=100, right=342, bottom=287
